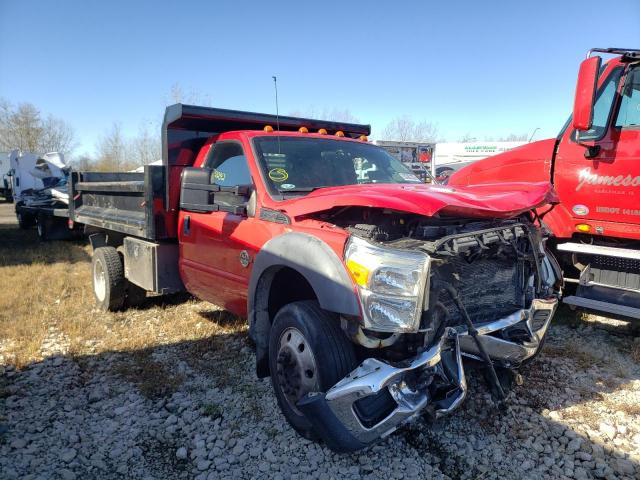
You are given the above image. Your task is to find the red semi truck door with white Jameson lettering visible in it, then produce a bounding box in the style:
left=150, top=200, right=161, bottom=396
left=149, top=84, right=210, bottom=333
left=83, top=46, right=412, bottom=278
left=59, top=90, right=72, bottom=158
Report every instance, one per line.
left=554, top=65, right=640, bottom=227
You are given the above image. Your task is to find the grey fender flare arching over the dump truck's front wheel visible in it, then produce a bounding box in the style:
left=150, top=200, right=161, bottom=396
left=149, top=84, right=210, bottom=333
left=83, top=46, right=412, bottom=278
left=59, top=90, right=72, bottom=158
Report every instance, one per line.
left=247, top=232, right=360, bottom=378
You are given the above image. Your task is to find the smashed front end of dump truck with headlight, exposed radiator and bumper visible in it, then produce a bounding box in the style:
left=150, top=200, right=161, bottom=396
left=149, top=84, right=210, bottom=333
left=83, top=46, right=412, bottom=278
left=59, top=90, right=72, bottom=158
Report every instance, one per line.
left=298, top=212, right=561, bottom=451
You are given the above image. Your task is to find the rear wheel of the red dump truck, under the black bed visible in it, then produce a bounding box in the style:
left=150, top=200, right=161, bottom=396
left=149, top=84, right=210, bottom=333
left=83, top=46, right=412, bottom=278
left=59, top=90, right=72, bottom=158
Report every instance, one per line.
left=91, top=247, right=127, bottom=312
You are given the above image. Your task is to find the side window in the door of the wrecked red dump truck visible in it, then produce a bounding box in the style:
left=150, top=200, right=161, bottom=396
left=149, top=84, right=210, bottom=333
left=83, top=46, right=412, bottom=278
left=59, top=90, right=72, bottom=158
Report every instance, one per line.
left=205, top=142, right=253, bottom=205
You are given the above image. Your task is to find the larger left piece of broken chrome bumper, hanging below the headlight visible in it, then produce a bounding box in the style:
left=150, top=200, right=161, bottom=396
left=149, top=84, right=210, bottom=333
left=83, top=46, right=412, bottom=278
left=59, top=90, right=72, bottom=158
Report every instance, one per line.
left=298, top=329, right=467, bottom=452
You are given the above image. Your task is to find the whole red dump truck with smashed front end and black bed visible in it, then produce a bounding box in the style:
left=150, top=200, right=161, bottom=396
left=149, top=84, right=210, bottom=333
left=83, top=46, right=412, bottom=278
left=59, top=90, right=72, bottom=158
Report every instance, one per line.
left=70, top=105, right=561, bottom=451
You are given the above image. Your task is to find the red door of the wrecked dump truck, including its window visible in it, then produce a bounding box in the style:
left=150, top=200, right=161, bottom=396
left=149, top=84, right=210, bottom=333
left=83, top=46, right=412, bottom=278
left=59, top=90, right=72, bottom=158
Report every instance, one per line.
left=179, top=141, right=255, bottom=315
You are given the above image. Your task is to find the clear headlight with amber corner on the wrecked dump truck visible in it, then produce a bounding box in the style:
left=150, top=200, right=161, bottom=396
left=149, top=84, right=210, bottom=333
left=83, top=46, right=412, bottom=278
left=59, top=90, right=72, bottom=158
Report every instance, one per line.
left=345, top=237, right=429, bottom=332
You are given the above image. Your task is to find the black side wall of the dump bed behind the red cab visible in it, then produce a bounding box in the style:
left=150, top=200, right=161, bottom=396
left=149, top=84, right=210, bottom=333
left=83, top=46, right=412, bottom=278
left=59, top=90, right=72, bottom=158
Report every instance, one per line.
left=69, top=165, right=171, bottom=240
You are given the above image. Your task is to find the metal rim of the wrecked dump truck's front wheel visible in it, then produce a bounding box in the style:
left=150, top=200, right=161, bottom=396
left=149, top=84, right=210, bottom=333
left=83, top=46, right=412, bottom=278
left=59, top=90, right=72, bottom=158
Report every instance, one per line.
left=276, top=327, right=319, bottom=415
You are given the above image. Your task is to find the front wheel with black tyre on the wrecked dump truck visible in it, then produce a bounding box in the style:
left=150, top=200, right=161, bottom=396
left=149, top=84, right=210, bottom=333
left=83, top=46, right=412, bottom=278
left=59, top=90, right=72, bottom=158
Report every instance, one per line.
left=269, top=301, right=357, bottom=439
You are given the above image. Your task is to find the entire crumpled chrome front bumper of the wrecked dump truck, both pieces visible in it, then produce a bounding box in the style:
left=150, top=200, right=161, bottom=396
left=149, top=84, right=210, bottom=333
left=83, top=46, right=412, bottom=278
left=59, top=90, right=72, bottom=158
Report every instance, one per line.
left=298, top=299, right=558, bottom=452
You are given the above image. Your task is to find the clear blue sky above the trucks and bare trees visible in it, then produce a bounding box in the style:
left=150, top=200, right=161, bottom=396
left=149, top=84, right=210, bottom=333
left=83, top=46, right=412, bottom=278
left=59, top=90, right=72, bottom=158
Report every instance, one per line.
left=0, top=0, right=640, bottom=154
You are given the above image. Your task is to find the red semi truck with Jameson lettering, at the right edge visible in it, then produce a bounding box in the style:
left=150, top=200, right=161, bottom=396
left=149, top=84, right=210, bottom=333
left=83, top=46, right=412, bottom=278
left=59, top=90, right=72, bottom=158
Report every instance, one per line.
left=448, top=48, right=640, bottom=320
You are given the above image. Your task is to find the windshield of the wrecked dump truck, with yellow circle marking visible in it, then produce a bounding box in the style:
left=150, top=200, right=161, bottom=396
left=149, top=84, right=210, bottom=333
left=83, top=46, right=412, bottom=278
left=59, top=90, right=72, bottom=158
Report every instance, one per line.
left=253, top=136, right=422, bottom=194
